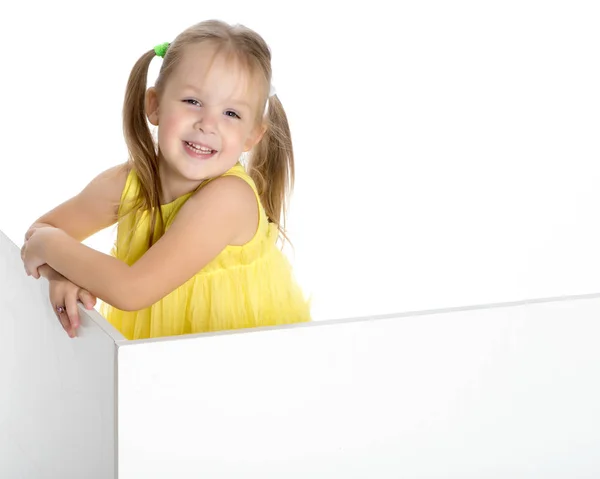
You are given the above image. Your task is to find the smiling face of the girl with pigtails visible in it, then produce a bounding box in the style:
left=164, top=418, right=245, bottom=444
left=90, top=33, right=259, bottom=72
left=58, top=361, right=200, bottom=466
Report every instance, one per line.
left=146, top=42, right=264, bottom=201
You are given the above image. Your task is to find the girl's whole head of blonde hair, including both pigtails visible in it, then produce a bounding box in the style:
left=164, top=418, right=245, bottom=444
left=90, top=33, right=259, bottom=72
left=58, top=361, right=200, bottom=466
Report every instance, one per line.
left=121, top=20, right=294, bottom=246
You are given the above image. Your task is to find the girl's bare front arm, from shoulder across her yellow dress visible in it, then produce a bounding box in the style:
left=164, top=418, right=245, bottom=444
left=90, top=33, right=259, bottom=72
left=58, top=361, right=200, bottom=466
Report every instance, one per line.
left=34, top=177, right=258, bottom=311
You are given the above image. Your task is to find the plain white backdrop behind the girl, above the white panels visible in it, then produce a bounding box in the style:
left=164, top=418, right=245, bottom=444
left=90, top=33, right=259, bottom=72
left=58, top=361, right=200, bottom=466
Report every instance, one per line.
left=0, top=0, right=600, bottom=319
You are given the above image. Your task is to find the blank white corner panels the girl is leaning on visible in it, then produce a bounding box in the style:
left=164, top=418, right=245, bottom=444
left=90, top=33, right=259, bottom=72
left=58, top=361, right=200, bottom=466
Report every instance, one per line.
left=0, top=233, right=600, bottom=479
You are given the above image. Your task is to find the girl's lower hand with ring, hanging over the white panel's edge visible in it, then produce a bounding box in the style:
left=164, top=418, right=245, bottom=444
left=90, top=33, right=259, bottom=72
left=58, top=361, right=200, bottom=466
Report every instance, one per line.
left=45, top=265, right=96, bottom=338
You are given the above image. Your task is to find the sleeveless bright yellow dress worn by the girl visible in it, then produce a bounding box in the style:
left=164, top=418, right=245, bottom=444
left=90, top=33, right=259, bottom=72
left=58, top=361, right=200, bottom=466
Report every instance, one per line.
left=100, top=163, right=310, bottom=339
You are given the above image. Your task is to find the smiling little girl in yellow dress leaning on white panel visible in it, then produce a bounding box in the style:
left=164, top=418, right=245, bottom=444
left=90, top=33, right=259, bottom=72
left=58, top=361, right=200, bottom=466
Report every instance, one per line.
left=22, top=21, right=310, bottom=339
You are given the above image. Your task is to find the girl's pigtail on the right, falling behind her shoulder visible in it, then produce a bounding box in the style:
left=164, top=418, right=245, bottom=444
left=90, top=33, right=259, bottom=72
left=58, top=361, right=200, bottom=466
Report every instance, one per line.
left=248, top=95, right=295, bottom=246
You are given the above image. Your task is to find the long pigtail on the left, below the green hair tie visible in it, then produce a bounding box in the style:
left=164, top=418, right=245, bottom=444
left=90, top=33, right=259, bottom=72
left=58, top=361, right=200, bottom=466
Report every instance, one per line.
left=123, top=50, right=164, bottom=247
